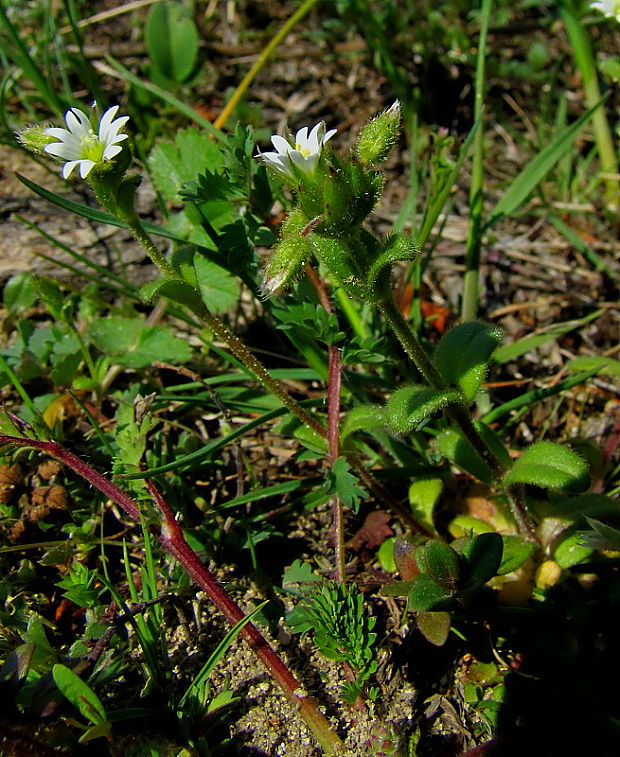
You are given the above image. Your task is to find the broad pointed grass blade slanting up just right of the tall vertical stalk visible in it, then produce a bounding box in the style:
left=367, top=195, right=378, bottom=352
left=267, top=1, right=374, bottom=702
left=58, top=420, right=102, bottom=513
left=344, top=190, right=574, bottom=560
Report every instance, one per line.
left=486, top=101, right=602, bottom=228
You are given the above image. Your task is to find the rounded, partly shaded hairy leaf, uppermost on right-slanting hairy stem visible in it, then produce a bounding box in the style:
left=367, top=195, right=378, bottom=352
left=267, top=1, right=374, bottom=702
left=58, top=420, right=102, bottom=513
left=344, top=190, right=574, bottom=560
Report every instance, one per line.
left=434, top=321, right=502, bottom=402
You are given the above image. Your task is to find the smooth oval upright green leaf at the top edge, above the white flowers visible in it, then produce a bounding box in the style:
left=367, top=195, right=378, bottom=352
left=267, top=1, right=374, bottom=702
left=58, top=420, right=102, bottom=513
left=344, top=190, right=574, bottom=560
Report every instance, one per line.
left=144, top=2, right=198, bottom=84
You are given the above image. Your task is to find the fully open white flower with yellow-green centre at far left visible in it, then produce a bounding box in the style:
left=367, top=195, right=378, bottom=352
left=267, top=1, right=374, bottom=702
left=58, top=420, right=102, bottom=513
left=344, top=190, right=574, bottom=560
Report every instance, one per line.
left=43, top=105, right=129, bottom=179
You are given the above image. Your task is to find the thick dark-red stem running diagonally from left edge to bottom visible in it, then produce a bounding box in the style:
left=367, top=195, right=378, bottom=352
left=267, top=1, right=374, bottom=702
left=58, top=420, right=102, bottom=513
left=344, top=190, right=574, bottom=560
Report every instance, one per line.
left=0, top=434, right=342, bottom=754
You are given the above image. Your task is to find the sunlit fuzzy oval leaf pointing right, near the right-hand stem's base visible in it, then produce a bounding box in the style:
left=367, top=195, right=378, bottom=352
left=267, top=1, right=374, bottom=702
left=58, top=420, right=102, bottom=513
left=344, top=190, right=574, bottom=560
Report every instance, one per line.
left=504, top=441, right=590, bottom=492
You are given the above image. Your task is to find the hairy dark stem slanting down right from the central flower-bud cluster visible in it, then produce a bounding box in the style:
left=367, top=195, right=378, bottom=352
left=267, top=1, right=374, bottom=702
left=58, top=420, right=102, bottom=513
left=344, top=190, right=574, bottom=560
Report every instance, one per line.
left=378, top=300, right=535, bottom=539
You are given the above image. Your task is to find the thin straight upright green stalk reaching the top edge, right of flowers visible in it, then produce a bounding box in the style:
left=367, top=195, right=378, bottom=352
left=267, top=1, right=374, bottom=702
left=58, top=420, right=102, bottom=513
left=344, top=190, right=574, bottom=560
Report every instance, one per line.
left=461, top=0, right=492, bottom=321
